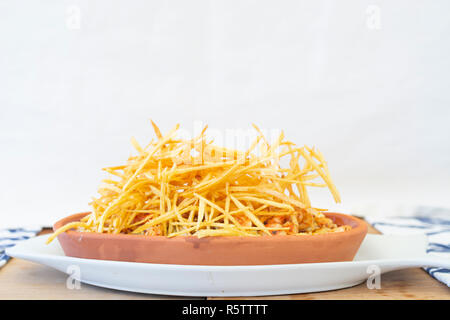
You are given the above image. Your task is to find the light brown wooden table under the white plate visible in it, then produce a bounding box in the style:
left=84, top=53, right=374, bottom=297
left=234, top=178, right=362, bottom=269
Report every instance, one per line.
left=0, top=222, right=450, bottom=300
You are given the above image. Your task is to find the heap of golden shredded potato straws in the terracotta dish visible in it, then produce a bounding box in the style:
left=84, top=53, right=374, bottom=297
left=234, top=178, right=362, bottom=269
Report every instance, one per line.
left=47, top=121, right=351, bottom=243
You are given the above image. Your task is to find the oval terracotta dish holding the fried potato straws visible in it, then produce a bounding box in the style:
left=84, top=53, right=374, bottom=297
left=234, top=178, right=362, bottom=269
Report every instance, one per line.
left=53, top=212, right=367, bottom=266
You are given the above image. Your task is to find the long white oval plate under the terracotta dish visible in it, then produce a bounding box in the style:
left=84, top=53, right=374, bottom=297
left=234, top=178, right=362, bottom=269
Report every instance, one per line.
left=7, top=235, right=450, bottom=297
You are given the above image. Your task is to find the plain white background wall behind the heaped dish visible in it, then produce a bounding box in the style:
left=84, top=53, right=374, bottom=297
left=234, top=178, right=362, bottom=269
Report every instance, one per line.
left=0, top=0, right=450, bottom=227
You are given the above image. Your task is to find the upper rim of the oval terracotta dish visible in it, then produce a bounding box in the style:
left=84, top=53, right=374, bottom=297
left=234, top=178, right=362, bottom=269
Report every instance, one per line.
left=53, top=211, right=368, bottom=242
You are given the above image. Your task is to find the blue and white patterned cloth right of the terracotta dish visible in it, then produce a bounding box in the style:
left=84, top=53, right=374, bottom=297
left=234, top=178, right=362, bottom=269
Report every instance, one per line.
left=365, top=207, right=450, bottom=287
